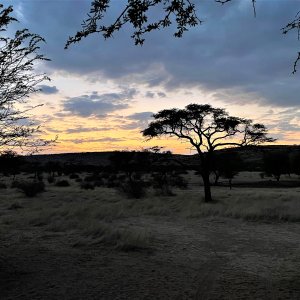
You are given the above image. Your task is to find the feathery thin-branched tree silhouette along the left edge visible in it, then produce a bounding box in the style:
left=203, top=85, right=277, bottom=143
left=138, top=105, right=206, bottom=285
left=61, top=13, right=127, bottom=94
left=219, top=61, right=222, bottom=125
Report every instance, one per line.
left=0, top=4, right=50, bottom=151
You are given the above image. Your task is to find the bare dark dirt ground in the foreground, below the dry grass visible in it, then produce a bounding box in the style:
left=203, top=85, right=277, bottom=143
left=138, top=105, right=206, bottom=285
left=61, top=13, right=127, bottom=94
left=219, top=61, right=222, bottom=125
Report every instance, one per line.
left=0, top=217, right=300, bottom=300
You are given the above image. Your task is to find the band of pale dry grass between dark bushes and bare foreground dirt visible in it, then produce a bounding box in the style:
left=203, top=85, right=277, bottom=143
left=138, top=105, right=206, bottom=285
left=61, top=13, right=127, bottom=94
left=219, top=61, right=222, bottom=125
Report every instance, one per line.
left=0, top=171, right=300, bottom=250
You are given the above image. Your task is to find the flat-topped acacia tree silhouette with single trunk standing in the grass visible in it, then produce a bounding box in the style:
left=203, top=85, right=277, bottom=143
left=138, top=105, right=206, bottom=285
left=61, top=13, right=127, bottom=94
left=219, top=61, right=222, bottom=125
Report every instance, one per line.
left=142, top=104, right=275, bottom=202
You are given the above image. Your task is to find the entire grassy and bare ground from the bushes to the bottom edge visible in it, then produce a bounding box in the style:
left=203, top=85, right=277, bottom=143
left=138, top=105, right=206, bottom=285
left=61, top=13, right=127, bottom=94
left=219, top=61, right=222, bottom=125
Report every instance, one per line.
left=0, top=171, right=300, bottom=299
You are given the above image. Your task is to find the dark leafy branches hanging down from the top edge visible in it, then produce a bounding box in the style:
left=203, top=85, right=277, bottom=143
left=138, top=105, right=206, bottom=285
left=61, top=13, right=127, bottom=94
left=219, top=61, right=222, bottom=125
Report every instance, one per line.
left=65, top=0, right=300, bottom=73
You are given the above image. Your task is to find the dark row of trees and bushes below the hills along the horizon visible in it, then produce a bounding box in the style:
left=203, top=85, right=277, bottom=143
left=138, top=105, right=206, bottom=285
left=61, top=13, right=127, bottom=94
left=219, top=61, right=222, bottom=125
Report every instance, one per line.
left=0, top=147, right=300, bottom=198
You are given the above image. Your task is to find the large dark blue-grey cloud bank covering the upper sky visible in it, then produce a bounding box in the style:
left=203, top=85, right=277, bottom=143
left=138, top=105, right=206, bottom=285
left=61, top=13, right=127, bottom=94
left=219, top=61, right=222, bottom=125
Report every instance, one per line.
left=4, top=0, right=300, bottom=107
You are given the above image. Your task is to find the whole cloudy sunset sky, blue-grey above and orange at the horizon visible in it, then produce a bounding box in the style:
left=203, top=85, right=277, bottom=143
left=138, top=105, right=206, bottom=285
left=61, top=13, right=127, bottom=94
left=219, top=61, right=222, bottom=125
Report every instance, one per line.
left=2, top=0, right=300, bottom=154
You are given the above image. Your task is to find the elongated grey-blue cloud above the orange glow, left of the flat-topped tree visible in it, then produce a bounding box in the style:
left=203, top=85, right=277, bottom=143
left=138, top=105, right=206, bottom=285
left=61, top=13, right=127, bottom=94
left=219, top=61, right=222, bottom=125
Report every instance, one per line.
left=63, top=88, right=137, bottom=117
